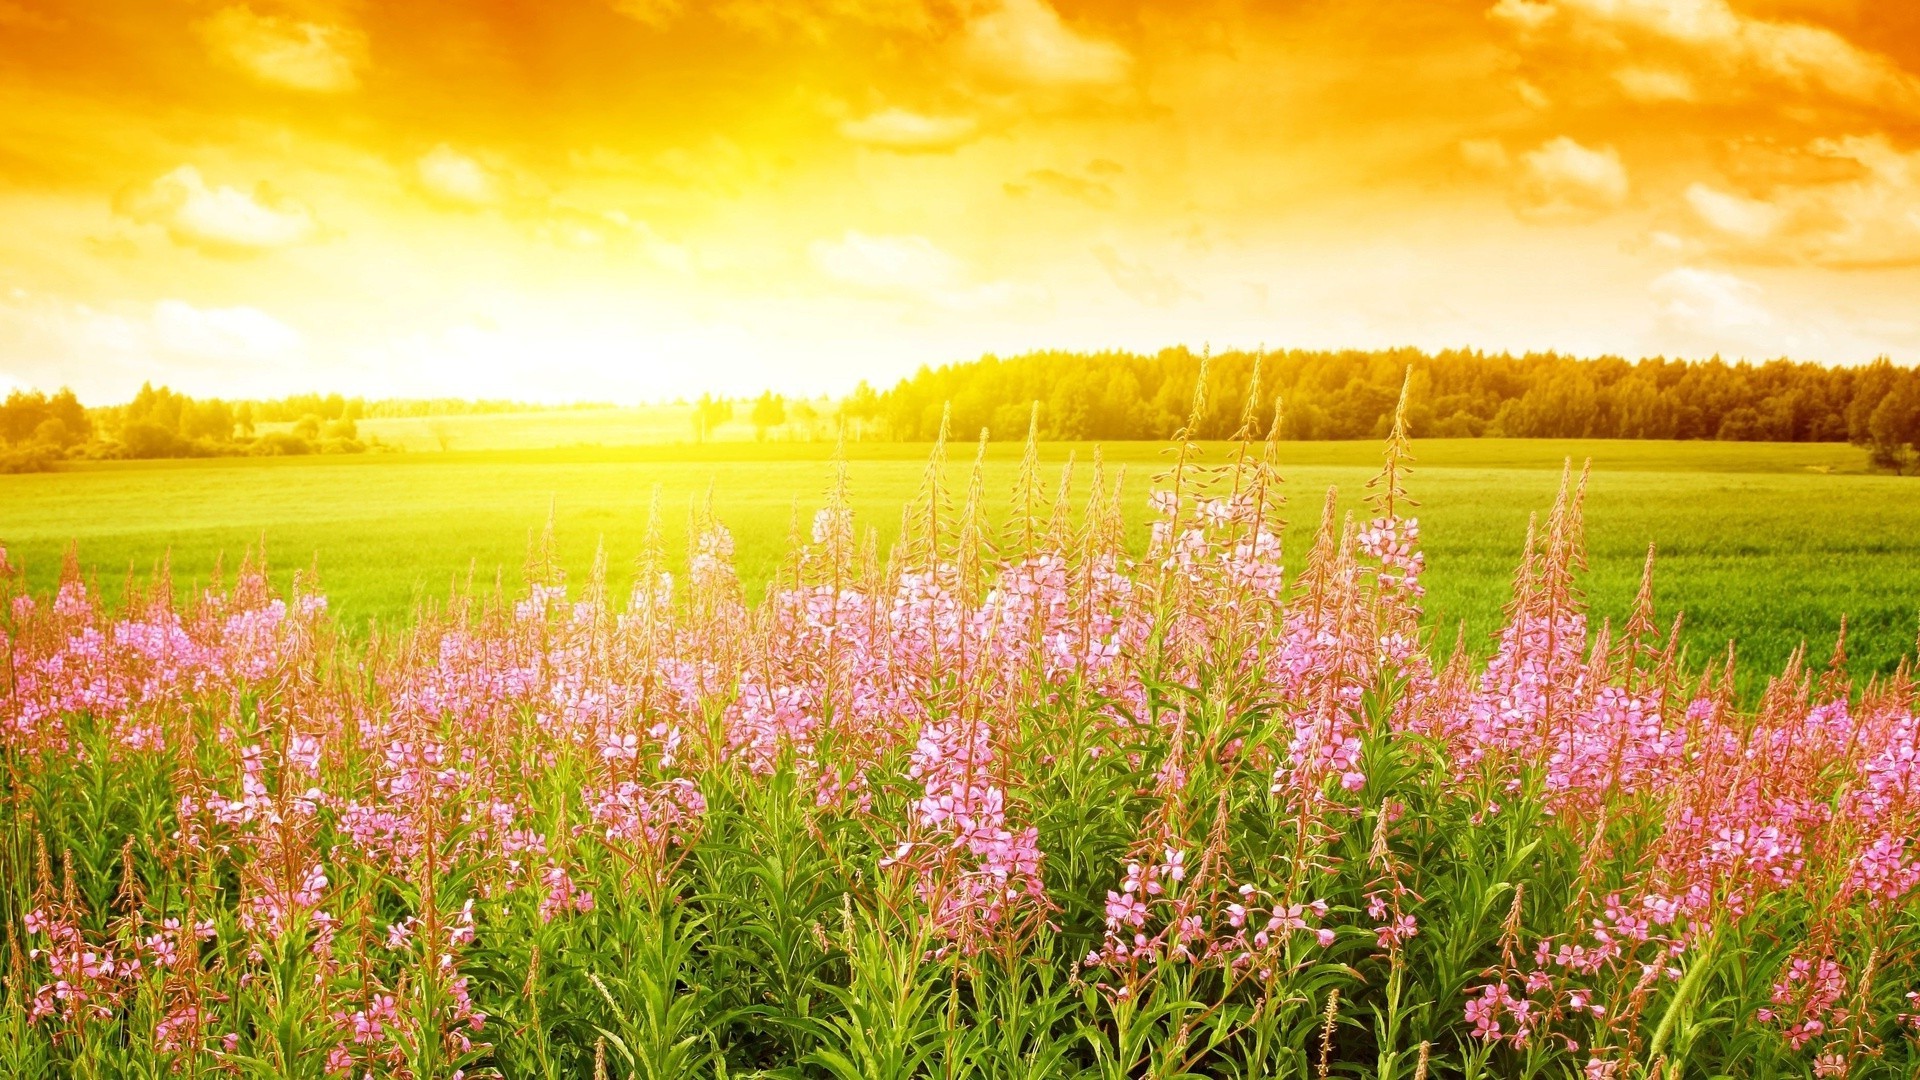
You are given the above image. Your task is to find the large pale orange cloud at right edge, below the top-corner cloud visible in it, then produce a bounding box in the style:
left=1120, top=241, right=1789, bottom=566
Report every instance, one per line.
left=1686, top=135, right=1920, bottom=267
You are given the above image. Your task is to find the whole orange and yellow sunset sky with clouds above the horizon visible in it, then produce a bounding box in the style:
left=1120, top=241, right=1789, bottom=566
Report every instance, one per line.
left=0, top=0, right=1920, bottom=404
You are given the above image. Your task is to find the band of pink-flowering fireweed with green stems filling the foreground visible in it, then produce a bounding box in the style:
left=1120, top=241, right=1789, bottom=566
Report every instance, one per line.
left=0, top=372, right=1920, bottom=1080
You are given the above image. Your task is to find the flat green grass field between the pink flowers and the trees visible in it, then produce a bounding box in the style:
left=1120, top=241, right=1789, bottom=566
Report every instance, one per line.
left=0, top=440, right=1920, bottom=688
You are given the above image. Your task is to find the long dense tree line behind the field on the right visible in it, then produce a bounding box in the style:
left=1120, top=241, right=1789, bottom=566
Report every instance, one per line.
left=856, top=348, right=1920, bottom=471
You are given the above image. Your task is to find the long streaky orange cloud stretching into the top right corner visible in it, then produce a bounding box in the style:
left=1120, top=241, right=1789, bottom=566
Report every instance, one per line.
left=1488, top=0, right=1920, bottom=115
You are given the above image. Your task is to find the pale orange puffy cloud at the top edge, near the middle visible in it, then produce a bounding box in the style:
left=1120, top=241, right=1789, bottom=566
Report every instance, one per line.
left=962, top=0, right=1133, bottom=88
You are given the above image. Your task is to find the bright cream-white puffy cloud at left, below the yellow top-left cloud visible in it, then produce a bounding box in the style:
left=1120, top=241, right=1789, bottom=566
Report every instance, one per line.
left=113, top=165, right=319, bottom=256
